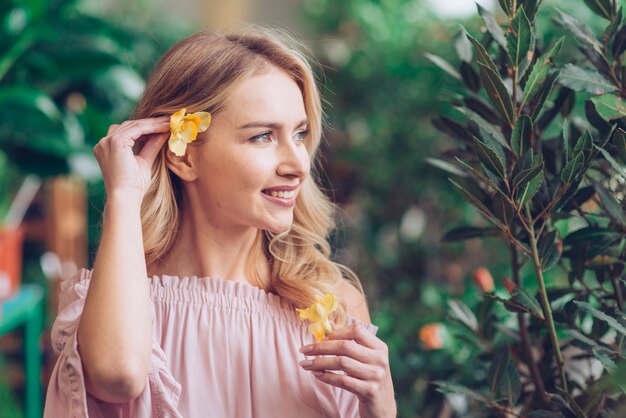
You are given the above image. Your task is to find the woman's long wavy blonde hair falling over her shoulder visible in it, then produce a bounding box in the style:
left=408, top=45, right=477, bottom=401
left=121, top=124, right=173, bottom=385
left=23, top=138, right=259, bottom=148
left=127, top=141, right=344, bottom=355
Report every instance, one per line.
left=133, top=29, right=363, bottom=324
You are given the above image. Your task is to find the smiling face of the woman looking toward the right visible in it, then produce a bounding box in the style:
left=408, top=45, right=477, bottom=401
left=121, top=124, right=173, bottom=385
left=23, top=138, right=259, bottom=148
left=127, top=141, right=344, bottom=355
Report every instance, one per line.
left=187, top=66, right=310, bottom=232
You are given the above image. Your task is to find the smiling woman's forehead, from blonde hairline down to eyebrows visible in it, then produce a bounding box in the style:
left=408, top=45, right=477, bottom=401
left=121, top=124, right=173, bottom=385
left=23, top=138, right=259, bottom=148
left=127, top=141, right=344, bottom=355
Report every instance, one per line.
left=220, top=65, right=306, bottom=123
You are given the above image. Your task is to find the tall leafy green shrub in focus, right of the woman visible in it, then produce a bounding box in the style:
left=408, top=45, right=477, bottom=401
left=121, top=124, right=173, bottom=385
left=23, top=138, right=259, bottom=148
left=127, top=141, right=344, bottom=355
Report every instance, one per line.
left=431, top=0, right=626, bottom=418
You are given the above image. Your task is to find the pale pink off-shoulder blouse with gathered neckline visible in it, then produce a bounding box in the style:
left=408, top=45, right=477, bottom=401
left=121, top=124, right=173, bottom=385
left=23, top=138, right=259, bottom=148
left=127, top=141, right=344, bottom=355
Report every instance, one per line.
left=44, top=269, right=378, bottom=418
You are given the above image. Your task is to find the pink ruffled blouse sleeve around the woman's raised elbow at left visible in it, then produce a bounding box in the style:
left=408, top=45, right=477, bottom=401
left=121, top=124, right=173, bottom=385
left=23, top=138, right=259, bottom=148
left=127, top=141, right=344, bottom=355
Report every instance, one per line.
left=44, top=269, right=182, bottom=418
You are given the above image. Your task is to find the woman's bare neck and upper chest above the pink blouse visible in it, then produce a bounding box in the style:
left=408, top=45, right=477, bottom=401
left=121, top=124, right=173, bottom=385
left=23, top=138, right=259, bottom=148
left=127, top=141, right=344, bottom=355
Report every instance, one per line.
left=148, top=195, right=269, bottom=289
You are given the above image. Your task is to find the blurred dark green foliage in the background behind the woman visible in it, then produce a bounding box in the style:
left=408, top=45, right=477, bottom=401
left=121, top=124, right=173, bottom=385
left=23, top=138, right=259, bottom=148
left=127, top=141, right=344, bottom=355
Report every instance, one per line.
left=0, top=0, right=620, bottom=417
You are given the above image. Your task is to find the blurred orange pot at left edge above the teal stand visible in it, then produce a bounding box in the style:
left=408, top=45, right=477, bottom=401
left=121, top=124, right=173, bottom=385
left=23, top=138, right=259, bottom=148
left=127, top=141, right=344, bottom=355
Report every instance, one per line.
left=0, top=226, right=24, bottom=300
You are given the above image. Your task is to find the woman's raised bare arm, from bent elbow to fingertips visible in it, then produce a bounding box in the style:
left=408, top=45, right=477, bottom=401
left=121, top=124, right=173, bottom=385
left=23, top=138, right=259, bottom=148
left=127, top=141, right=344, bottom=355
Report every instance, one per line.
left=77, top=119, right=167, bottom=402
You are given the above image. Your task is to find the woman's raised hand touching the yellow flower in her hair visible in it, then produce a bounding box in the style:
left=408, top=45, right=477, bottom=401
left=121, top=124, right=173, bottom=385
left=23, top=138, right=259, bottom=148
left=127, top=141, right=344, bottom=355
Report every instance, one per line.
left=93, top=116, right=169, bottom=200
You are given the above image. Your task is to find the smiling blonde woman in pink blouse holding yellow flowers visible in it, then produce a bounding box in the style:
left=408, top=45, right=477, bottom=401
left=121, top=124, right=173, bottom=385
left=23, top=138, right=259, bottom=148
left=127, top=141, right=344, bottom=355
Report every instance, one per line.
left=45, top=33, right=396, bottom=418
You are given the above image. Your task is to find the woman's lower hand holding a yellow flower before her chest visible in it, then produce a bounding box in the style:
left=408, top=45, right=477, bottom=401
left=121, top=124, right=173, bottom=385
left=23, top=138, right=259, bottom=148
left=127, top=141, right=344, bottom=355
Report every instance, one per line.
left=300, top=323, right=397, bottom=418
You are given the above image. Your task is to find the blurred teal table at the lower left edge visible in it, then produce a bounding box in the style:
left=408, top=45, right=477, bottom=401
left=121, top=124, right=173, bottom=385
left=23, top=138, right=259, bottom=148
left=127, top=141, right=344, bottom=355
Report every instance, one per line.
left=0, top=284, right=44, bottom=418
